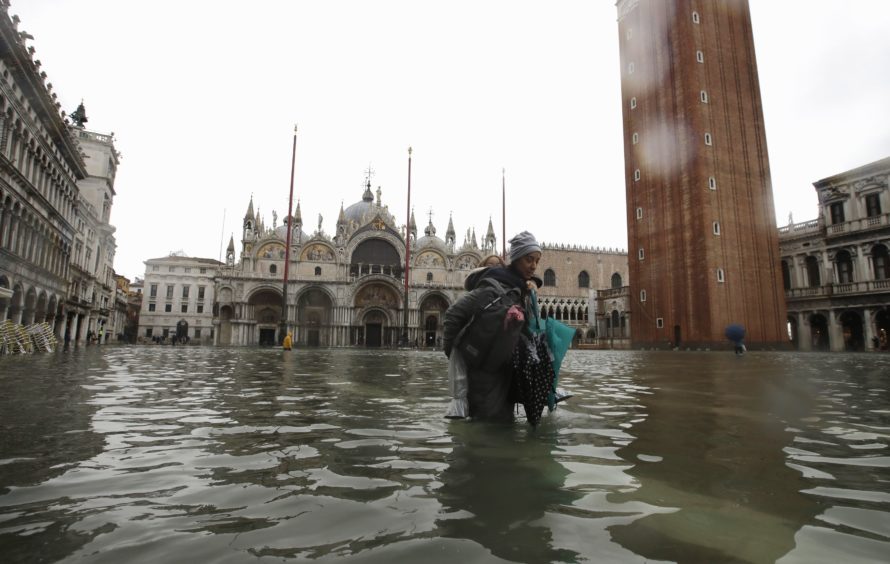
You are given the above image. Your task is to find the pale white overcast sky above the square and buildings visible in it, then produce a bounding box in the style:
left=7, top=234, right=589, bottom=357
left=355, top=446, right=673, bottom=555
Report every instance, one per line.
left=10, top=0, right=890, bottom=279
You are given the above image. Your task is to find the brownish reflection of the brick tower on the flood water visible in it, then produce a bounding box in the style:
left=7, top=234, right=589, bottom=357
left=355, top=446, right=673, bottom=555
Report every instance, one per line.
left=610, top=353, right=818, bottom=562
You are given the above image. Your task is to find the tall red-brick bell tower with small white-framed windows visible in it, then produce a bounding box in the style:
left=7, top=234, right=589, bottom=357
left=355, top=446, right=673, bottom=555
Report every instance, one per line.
left=616, top=0, right=788, bottom=348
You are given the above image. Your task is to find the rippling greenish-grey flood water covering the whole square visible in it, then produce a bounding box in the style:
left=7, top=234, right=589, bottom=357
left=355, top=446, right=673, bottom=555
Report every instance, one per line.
left=0, top=347, right=890, bottom=564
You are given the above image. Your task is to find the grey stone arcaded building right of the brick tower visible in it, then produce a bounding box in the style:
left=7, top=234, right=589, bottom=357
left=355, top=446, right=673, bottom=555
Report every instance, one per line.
left=779, top=157, right=890, bottom=351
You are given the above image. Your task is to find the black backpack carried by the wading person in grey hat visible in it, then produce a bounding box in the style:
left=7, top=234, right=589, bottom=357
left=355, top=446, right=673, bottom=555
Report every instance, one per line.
left=455, top=278, right=522, bottom=372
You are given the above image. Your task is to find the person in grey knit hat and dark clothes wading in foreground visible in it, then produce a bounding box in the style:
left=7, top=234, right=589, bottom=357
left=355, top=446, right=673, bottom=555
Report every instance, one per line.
left=443, top=231, right=541, bottom=421
